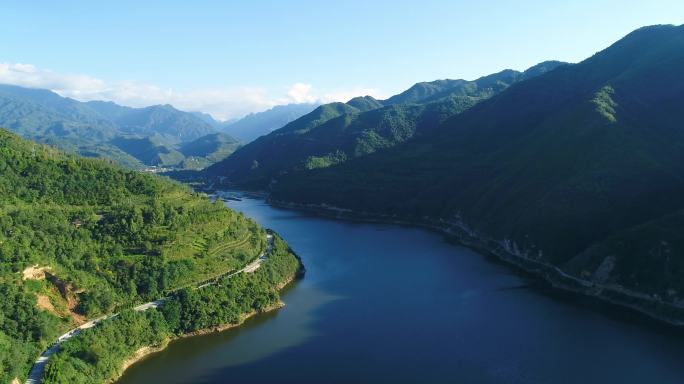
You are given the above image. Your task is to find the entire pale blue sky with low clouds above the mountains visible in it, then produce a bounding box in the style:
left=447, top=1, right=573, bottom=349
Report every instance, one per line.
left=0, top=0, right=684, bottom=118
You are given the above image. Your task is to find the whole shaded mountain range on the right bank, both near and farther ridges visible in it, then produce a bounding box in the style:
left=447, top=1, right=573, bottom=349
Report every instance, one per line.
left=200, top=25, right=684, bottom=321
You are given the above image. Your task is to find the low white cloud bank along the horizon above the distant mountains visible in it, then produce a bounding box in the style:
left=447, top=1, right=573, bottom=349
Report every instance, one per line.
left=0, top=63, right=381, bottom=120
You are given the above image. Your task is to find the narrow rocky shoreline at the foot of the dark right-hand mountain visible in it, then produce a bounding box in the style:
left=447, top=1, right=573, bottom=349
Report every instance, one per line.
left=266, top=198, right=684, bottom=329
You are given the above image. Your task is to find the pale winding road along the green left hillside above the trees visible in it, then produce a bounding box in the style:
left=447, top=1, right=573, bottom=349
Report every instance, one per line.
left=25, top=233, right=273, bottom=384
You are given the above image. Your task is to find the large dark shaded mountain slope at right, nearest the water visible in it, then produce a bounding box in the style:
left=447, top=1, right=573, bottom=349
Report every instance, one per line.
left=273, top=26, right=684, bottom=308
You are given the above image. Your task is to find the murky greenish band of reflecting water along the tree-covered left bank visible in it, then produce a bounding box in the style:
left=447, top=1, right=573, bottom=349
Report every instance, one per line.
left=117, top=280, right=341, bottom=384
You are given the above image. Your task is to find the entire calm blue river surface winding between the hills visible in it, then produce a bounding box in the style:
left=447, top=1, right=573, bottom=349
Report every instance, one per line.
left=119, top=195, right=684, bottom=384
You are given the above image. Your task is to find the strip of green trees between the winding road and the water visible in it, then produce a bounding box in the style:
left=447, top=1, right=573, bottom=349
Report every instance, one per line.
left=42, top=239, right=301, bottom=384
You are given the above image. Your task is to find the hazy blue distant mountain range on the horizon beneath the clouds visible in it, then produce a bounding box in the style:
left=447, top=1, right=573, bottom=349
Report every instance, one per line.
left=0, top=85, right=314, bottom=169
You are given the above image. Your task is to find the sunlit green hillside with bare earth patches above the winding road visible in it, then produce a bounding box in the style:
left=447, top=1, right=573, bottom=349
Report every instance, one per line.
left=0, top=130, right=296, bottom=382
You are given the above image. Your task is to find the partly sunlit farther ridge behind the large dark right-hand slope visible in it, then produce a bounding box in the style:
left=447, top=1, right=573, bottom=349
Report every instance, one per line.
left=206, top=62, right=562, bottom=188
